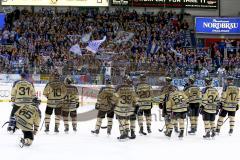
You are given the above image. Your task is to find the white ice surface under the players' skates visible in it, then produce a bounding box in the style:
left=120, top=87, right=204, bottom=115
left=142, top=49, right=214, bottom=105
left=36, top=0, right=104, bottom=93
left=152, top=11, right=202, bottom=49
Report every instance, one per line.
left=0, top=97, right=240, bottom=160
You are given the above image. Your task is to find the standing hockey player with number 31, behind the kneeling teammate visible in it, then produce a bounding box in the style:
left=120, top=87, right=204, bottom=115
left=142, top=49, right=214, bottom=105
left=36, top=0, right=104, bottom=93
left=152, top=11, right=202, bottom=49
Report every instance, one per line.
left=7, top=73, right=36, bottom=132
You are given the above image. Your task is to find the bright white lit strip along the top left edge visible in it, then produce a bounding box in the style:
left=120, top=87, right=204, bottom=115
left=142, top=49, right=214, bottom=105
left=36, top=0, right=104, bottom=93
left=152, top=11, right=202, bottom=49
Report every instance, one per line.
left=2, top=0, right=109, bottom=7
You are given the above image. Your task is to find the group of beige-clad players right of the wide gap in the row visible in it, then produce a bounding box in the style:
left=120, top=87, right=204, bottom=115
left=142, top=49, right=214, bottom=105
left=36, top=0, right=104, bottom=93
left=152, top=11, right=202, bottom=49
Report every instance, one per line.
left=92, top=75, right=240, bottom=140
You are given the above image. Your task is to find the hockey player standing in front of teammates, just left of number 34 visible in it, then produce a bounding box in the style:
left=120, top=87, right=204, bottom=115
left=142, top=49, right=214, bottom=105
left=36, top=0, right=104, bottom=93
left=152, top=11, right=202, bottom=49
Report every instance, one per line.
left=165, top=89, right=188, bottom=138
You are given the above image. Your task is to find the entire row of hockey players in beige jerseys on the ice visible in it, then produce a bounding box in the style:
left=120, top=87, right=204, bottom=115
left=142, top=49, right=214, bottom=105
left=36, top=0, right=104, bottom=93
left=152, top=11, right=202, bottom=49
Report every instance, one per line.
left=5, top=72, right=240, bottom=145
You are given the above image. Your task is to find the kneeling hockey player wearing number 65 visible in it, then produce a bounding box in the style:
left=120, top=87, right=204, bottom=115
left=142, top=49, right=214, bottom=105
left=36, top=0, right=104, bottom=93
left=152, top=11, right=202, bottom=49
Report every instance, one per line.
left=15, top=97, right=41, bottom=147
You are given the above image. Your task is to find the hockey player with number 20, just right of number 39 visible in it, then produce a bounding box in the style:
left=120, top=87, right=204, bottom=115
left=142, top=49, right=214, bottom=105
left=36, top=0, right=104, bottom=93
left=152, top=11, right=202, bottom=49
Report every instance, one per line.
left=136, top=75, right=153, bottom=135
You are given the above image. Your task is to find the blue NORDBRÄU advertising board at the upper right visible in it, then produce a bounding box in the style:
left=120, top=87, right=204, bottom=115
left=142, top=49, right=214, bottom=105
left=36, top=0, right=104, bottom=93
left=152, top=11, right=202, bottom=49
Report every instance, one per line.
left=195, top=17, right=240, bottom=34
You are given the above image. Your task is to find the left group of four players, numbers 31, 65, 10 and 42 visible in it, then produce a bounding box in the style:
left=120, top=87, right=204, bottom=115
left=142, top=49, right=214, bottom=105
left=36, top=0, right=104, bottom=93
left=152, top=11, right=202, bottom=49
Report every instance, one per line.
left=8, top=72, right=79, bottom=147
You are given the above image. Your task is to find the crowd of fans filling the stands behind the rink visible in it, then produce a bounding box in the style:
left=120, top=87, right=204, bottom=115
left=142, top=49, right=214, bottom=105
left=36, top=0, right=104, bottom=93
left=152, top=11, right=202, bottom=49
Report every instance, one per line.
left=0, top=9, right=240, bottom=85
